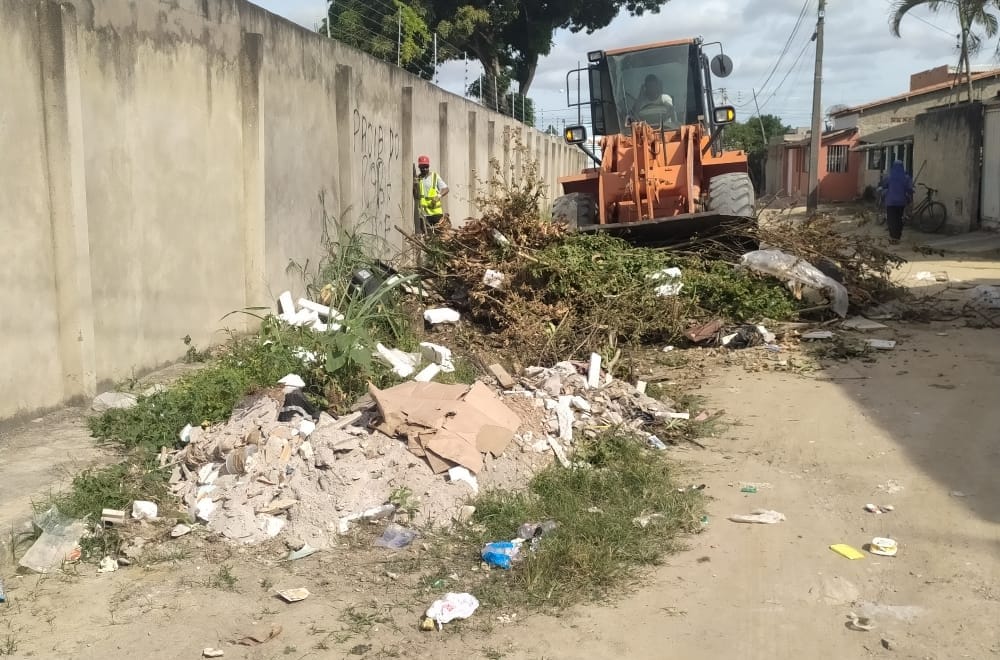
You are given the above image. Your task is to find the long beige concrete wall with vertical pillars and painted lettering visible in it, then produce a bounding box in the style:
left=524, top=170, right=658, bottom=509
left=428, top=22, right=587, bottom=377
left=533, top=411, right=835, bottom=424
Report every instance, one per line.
left=0, top=0, right=584, bottom=419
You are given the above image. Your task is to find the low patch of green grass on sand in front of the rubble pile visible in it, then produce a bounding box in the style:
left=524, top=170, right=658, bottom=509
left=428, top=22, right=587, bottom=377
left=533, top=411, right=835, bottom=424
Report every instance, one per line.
left=473, top=432, right=703, bottom=609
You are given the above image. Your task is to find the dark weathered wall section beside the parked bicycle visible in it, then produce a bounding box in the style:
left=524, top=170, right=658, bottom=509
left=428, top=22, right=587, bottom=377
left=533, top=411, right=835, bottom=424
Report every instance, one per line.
left=913, top=103, right=983, bottom=233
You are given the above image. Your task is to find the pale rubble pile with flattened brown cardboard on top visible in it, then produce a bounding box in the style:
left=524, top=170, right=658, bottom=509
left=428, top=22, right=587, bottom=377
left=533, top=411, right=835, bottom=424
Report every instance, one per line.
left=165, top=348, right=687, bottom=548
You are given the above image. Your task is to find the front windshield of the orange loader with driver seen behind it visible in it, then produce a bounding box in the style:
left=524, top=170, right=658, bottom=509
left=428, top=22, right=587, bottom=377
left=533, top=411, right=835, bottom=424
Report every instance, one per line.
left=608, top=45, right=704, bottom=133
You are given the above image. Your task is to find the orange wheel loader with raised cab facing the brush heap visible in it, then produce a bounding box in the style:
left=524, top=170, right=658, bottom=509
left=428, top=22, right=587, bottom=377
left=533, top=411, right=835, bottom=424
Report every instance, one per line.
left=552, top=39, right=755, bottom=243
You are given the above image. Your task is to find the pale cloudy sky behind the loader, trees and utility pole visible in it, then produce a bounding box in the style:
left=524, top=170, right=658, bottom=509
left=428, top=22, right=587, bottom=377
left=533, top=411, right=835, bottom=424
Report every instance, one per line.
left=252, top=0, right=980, bottom=127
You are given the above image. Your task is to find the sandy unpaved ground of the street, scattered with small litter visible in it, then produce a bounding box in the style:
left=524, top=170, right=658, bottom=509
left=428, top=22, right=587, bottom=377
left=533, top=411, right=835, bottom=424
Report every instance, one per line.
left=0, top=224, right=1000, bottom=660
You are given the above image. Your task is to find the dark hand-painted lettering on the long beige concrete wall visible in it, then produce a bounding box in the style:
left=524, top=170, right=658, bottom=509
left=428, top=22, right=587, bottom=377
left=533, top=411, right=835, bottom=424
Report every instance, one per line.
left=353, top=108, right=403, bottom=237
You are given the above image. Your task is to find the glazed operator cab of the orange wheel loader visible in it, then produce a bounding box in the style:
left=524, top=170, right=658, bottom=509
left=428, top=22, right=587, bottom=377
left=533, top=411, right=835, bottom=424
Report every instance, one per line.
left=580, top=40, right=731, bottom=135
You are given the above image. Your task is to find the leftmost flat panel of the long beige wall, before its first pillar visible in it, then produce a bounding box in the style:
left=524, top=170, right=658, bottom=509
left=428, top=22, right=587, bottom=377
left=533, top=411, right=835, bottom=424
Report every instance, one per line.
left=0, top=0, right=63, bottom=416
